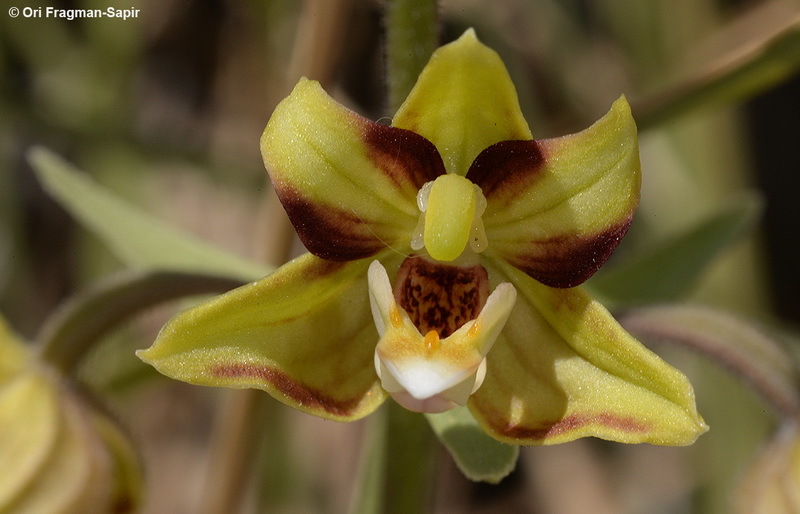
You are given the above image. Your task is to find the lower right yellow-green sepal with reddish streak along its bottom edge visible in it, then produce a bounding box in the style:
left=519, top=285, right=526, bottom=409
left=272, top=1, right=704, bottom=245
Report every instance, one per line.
left=469, top=263, right=707, bottom=445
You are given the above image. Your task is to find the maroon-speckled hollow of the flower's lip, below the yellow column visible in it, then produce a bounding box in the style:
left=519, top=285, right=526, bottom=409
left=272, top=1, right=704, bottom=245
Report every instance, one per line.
left=394, top=257, right=489, bottom=338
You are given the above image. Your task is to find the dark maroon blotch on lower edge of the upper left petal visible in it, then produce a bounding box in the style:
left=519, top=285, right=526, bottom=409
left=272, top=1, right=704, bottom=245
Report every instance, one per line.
left=275, top=185, right=386, bottom=261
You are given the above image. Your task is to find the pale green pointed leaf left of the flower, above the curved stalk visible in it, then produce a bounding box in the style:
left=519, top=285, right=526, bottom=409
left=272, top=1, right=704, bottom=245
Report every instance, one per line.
left=28, top=147, right=272, bottom=281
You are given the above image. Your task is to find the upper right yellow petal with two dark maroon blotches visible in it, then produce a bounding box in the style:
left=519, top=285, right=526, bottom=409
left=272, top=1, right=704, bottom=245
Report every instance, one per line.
left=467, top=97, right=641, bottom=287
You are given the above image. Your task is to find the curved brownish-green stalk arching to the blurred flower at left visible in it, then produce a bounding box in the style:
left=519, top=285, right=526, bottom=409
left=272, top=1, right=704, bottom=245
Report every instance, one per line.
left=37, top=271, right=242, bottom=374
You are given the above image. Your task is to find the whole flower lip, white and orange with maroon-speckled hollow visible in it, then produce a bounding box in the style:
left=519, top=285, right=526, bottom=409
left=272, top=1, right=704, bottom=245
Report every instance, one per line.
left=368, top=257, right=517, bottom=412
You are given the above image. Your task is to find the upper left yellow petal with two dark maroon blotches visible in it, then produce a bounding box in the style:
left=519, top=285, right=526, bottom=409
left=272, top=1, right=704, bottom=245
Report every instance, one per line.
left=261, top=79, right=444, bottom=260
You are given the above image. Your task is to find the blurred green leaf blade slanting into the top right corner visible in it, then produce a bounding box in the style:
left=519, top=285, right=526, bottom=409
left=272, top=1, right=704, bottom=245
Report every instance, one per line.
left=633, top=8, right=800, bottom=129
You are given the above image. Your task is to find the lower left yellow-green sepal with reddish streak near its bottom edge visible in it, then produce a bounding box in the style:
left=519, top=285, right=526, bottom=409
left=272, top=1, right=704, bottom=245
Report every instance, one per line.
left=137, top=254, right=385, bottom=420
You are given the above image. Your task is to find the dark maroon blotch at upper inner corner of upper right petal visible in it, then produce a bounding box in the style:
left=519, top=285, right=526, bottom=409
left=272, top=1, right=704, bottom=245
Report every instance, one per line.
left=467, top=140, right=545, bottom=201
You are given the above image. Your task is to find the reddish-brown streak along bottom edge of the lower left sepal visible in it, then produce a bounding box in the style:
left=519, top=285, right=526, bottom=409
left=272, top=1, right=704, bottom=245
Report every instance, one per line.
left=210, top=363, right=366, bottom=417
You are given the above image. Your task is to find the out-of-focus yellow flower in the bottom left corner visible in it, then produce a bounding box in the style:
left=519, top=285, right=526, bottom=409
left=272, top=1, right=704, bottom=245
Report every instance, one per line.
left=0, top=319, right=142, bottom=514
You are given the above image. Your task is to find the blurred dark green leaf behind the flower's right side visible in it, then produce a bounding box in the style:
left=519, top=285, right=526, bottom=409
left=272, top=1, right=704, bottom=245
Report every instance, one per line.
left=587, top=194, right=761, bottom=307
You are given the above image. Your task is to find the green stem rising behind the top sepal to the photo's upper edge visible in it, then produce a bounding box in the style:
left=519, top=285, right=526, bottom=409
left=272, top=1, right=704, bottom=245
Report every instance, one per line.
left=386, top=0, right=439, bottom=115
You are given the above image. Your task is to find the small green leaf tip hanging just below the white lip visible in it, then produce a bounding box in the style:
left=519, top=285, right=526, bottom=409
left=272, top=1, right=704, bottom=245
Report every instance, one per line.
left=425, top=407, right=519, bottom=484
